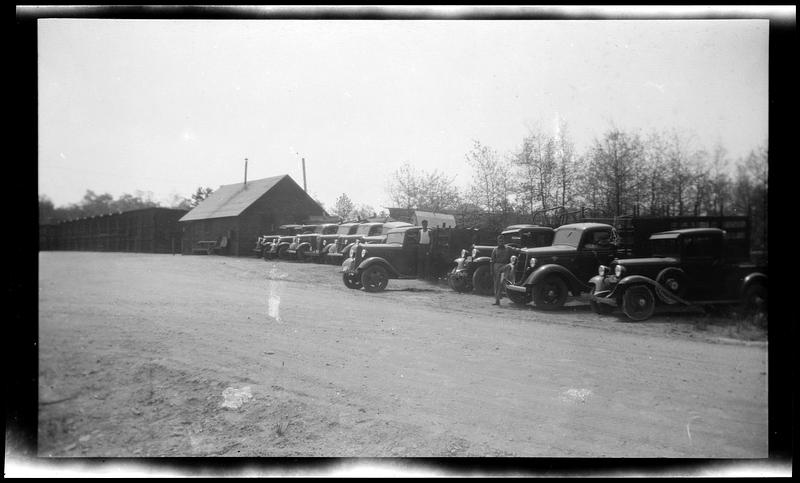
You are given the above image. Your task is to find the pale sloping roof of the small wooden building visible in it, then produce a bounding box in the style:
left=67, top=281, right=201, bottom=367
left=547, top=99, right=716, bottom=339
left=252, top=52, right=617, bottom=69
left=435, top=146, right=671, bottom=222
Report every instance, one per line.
left=178, top=174, right=291, bottom=221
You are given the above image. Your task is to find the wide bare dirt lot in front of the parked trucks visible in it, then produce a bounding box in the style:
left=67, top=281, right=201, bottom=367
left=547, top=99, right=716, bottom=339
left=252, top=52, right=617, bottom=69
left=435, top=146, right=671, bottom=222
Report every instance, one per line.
left=38, top=252, right=768, bottom=466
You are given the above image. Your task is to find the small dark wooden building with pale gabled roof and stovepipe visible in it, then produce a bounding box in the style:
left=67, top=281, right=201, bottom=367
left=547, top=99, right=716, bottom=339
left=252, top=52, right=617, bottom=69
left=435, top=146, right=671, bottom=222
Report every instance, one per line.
left=180, top=175, right=327, bottom=256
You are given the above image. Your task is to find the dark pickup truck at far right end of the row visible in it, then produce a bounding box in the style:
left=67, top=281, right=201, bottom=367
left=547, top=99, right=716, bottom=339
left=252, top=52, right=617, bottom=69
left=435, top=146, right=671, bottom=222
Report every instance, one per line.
left=590, top=228, right=767, bottom=321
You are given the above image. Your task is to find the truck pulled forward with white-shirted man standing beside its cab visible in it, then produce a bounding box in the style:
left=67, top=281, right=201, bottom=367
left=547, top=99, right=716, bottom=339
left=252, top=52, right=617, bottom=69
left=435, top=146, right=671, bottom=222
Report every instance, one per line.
left=342, top=226, right=422, bottom=292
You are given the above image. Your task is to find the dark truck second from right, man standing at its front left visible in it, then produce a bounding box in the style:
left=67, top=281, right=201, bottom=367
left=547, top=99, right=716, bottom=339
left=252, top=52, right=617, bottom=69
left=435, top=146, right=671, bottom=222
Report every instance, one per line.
left=505, top=223, right=620, bottom=310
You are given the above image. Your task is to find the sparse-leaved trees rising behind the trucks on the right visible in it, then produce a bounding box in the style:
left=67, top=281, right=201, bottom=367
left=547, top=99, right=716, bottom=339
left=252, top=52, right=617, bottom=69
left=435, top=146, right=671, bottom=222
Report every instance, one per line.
left=387, top=122, right=768, bottom=248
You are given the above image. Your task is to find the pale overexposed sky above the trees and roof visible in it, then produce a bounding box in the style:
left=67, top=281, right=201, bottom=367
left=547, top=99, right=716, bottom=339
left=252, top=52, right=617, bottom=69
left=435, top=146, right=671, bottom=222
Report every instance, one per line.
left=38, top=11, right=769, bottom=210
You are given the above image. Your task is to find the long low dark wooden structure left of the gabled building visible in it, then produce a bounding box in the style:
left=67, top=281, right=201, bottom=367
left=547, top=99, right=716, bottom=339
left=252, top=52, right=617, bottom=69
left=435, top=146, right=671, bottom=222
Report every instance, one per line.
left=46, top=207, right=186, bottom=253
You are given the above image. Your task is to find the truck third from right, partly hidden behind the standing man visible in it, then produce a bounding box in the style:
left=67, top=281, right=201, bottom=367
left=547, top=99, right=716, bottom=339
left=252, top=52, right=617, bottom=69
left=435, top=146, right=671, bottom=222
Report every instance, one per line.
left=448, top=225, right=554, bottom=295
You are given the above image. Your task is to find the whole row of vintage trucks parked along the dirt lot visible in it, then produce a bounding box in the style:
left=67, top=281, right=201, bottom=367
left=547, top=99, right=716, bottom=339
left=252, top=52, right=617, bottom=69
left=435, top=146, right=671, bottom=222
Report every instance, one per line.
left=256, top=217, right=767, bottom=321
